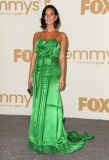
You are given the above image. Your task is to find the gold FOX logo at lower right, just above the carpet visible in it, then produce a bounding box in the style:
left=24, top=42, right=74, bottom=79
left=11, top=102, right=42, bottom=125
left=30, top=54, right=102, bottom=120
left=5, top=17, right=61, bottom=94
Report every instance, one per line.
left=79, top=97, right=109, bottom=112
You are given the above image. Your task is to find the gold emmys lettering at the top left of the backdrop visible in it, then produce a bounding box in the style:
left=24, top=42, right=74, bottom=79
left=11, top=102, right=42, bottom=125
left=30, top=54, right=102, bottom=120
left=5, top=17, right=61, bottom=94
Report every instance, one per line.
left=0, top=0, right=39, bottom=15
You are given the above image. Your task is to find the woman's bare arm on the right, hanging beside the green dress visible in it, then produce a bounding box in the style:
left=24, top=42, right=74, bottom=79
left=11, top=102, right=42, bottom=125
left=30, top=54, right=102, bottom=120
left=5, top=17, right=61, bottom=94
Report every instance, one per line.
left=59, top=33, right=67, bottom=89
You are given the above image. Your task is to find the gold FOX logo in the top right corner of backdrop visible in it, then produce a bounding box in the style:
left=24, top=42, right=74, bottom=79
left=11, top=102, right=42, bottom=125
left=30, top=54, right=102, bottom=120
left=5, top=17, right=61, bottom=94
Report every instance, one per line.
left=81, top=0, right=109, bottom=15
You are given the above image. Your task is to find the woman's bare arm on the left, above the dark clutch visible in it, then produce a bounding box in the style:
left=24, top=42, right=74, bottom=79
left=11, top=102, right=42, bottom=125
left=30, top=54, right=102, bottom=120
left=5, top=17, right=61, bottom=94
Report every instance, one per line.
left=28, top=33, right=38, bottom=85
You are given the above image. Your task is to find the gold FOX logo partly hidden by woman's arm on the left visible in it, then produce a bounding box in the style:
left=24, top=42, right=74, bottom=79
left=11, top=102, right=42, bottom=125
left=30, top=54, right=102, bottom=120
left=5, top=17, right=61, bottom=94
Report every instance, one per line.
left=14, top=49, right=32, bottom=62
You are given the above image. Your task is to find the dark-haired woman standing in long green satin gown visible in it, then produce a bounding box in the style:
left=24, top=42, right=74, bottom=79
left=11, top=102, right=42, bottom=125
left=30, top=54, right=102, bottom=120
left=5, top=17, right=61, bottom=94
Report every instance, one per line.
left=28, top=5, right=93, bottom=154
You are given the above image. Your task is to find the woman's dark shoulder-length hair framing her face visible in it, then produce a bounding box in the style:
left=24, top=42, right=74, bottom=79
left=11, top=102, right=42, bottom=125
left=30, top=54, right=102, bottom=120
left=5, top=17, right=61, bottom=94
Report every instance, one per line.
left=40, top=5, right=60, bottom=29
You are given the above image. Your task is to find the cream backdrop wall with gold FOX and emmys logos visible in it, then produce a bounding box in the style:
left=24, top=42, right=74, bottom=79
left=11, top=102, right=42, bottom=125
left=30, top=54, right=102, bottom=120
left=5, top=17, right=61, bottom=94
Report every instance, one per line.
left=0, top=0, right=109, bottom=120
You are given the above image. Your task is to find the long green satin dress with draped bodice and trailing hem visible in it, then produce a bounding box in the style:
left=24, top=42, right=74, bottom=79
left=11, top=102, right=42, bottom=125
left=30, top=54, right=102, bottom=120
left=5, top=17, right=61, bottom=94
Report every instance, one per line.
left=28, top=32, right=93, bottom=154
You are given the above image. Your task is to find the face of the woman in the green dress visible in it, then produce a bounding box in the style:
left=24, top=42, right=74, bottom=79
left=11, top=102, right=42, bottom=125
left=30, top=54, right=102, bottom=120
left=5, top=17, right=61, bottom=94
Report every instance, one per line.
left=44, top=8, right=57, bottom=25
